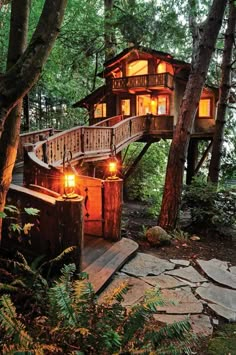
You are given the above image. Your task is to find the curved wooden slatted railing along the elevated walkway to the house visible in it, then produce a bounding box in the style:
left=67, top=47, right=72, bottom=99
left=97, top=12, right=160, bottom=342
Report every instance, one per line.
left=26, top=114, right=173, bottom=167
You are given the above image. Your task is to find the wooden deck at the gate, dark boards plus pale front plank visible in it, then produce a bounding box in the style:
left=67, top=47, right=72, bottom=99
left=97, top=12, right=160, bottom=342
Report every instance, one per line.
left=82, top=236, right=138, bottom=292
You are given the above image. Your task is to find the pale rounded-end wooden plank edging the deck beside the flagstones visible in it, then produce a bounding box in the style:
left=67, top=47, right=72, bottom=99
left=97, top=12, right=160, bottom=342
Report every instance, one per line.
left=83, top=238, right=138, bottom=292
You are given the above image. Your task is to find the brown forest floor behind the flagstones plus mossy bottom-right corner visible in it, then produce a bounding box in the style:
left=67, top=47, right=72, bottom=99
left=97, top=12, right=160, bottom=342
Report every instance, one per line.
left=122, top=202, right=236, bottom=355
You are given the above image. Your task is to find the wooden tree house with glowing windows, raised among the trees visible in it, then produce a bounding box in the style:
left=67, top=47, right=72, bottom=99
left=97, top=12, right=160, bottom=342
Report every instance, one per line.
left=73, top=47, right=218, bottom=183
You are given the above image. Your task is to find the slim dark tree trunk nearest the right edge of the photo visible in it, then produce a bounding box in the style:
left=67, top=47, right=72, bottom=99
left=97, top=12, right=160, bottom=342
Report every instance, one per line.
left=208, top=1, right=236, bottom=184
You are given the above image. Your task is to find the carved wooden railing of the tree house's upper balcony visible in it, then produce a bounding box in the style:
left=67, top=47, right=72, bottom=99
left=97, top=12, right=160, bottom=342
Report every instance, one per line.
left=111, top=73, right=174, bottom=91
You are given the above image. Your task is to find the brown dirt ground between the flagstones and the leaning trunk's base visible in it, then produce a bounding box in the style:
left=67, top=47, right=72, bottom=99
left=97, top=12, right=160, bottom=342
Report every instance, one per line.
left=122, top=202, right=236, bottom=265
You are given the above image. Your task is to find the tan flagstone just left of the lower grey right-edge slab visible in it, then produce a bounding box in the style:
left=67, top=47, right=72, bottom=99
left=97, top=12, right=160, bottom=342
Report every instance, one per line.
left=158, top=287, right=203, bottom=314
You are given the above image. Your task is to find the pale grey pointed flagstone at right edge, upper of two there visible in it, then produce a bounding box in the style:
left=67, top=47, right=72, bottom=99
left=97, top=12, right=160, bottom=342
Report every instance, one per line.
left=197, top=259, right=236, bottom=289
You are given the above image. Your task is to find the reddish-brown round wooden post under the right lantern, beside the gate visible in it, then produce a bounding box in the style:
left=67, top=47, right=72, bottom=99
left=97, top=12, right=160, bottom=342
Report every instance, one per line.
left=103, top=179, right=123, bottom=241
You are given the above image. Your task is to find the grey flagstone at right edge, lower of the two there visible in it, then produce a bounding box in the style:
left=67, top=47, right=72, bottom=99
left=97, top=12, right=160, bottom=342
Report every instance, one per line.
left=196, top=283, right=236, bottom=313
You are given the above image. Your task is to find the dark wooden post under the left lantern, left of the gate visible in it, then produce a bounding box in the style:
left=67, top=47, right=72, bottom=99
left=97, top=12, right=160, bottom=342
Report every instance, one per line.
left=56, top=196, right=84, bottom=271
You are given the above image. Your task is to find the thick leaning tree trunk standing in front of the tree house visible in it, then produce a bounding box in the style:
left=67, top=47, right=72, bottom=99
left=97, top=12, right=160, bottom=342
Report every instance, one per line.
left=159, top=0, right=227, bottom=229
